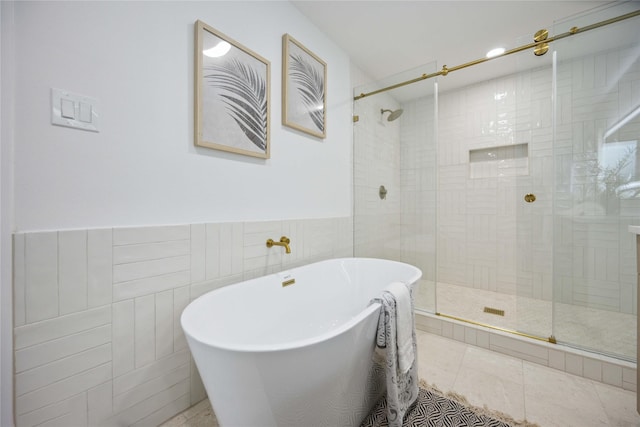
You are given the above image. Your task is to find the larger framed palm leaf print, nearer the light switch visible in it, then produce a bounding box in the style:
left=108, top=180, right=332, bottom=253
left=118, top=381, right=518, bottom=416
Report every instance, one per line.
left=195, top=21, right=271, bottom=159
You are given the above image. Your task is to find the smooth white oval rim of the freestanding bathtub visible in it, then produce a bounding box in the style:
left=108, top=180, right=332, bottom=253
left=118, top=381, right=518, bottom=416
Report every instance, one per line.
left=180, top=257, right=422, bottom=353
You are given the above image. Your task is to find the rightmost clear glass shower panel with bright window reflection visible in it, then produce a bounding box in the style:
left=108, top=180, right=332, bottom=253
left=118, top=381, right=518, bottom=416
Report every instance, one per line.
left=552, top=2, right=640, bottom=361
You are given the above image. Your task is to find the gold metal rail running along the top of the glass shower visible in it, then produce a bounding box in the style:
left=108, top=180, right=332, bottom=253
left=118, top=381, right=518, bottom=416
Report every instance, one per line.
left=353, top=10, right=640, bottom=101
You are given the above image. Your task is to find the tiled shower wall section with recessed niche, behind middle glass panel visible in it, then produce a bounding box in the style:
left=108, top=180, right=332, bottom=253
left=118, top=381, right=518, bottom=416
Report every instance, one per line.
left=438, top=69, right=553, bottom=299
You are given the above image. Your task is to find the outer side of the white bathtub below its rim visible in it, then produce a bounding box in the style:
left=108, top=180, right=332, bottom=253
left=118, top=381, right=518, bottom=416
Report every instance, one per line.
left=189, top=316, right=385, bottom=427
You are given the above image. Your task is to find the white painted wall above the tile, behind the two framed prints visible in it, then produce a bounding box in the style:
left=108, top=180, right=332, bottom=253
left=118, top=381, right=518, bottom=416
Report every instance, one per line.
left=15, top=1, right=352, bottom=231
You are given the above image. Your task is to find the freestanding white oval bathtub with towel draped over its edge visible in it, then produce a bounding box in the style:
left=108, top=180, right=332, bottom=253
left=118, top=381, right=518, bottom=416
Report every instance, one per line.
left=181, top=258, right=422, bottom=427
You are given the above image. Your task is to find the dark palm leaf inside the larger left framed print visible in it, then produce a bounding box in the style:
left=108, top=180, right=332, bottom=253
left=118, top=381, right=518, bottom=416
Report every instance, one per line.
left=203, top=59, right=267, bottom=151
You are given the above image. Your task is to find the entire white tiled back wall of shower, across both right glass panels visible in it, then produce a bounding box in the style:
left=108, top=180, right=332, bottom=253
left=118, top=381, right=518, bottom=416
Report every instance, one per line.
left=428, top=41, right=640, bottom=313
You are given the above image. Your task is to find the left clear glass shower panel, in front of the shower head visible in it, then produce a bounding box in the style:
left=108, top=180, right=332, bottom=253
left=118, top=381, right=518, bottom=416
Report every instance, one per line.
left=353, top=63, right=437, bottom=312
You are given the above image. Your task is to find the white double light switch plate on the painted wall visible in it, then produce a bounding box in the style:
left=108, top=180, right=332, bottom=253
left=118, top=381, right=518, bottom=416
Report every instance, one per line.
left=51, top=88, right=100, bottom=132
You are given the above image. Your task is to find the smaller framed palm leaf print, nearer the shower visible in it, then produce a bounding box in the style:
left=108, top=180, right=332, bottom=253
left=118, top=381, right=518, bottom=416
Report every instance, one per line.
left=282, top=34, right=327, bottom=138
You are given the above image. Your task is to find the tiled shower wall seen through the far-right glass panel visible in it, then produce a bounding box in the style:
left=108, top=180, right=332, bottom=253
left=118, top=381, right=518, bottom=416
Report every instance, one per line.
left=554, top=46, right=640, bottom=314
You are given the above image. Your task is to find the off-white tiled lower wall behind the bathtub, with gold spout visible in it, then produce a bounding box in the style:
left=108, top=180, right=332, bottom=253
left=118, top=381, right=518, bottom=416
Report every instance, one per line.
left=14, top=217, right=353, bottom=426
